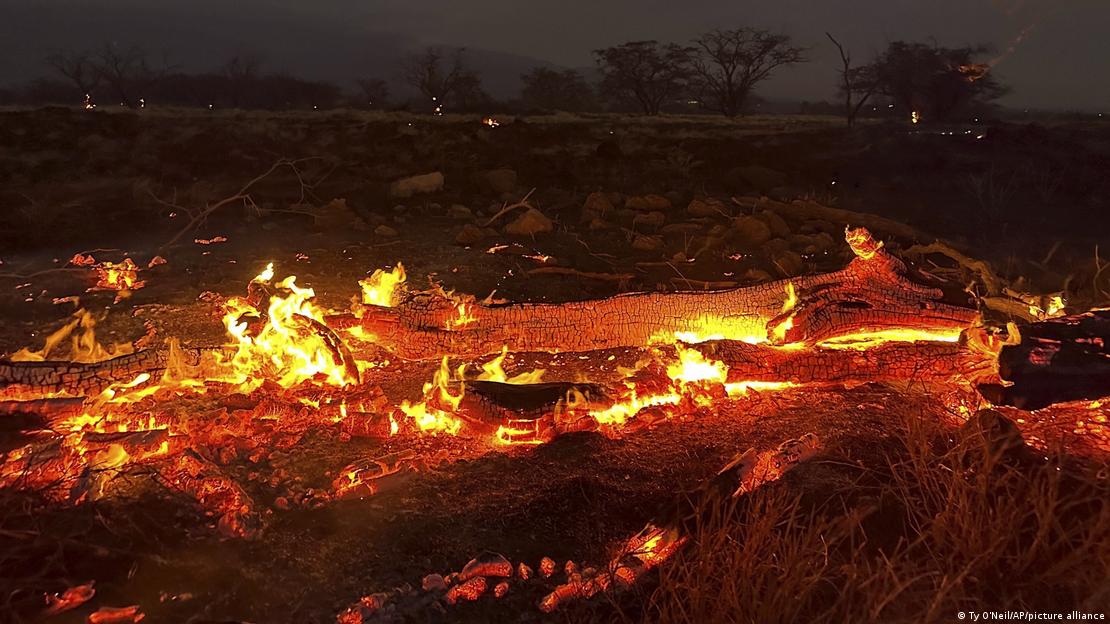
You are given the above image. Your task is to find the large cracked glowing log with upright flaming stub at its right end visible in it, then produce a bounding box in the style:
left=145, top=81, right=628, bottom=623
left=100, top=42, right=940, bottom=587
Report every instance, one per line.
left=339, top=230, right=978, bottom=359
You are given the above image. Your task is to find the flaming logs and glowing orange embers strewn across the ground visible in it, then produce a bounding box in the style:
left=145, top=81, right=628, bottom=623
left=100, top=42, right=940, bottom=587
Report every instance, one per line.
left=0, top=229, right=1110, bottom=623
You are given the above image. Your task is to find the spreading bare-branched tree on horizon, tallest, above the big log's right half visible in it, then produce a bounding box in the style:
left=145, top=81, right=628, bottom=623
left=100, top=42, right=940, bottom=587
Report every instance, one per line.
left=692, top=28, right=806, bottom=117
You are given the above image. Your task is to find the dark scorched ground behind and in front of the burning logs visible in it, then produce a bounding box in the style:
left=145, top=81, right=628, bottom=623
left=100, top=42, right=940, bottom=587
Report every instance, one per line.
left=0, top=109, right=1110, bottom=622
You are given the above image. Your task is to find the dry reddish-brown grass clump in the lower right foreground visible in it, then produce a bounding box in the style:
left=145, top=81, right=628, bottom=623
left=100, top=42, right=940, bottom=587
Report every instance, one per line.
left=623, top=413, right=1110, bottom=623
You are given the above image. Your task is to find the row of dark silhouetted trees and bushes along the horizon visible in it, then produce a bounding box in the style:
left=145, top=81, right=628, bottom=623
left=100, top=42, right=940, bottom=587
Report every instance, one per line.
left=0, top=28, right=1006, bottom=125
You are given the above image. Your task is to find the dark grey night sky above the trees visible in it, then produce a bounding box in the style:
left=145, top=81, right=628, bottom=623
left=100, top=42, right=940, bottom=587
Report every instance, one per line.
left=0, top=0, right=1110, bottom=110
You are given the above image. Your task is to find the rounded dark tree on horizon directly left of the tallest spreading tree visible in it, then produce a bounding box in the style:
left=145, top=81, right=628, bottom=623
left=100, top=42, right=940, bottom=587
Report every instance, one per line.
left=594, top=41, right=690, bottom=114
